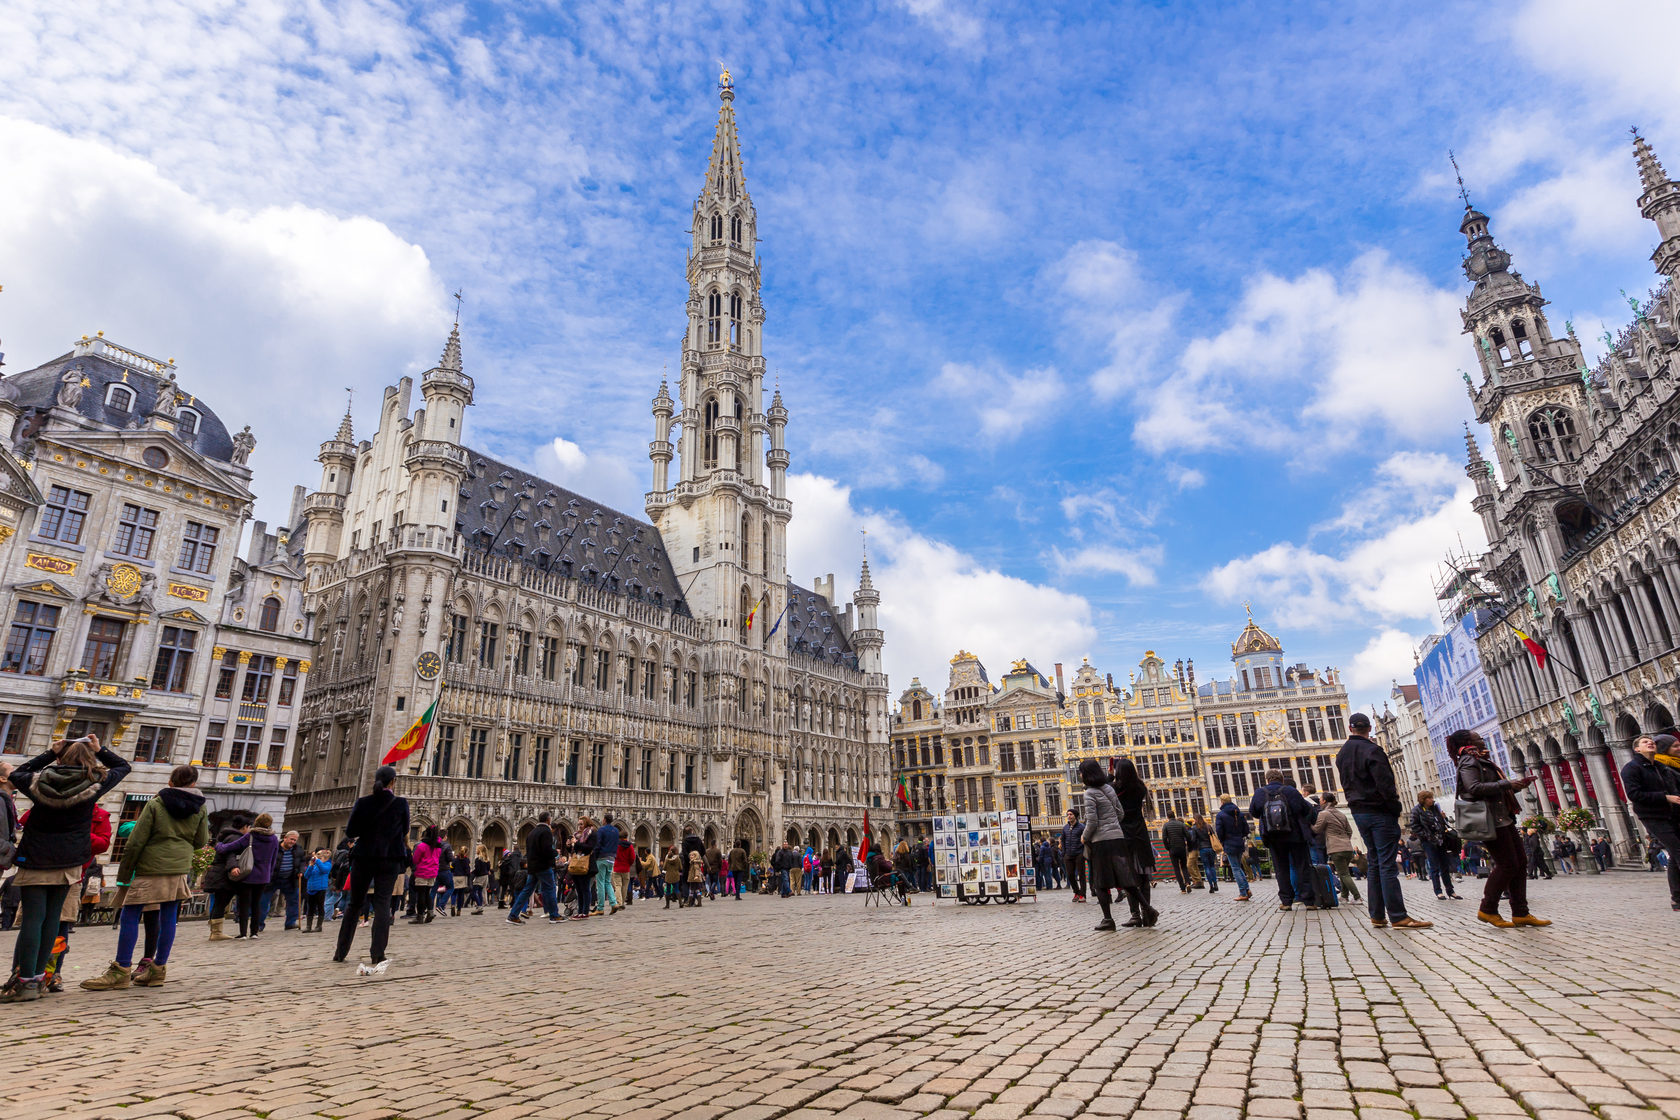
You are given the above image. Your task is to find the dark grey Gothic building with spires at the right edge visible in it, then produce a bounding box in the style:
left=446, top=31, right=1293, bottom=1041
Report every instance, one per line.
left=1460, top=134, right=1680, bottom=858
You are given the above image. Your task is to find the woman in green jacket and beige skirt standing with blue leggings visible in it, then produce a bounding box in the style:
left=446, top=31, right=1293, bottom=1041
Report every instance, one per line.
left=82, top=766, right=210, bottom=992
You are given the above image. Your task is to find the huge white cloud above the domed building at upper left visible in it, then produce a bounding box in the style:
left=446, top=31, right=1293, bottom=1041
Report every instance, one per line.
left=0, top=118, right=449, bottom=521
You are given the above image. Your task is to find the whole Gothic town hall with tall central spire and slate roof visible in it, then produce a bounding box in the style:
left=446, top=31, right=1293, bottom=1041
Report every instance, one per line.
left=292, top=76, right=894, bottom=850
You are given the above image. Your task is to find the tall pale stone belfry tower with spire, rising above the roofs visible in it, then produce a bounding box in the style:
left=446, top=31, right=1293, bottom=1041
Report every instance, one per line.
left=647, top=71, right=793, bottom=648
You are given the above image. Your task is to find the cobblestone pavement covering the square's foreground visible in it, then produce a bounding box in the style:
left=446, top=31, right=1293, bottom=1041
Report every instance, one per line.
left=0, top=873, right=1680, bottom=1120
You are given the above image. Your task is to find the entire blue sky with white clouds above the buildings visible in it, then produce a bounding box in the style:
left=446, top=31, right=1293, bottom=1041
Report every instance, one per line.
left=0, top=0, right=1680, bottom=715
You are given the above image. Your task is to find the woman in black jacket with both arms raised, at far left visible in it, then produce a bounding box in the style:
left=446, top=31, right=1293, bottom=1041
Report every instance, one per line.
left=0, top=735, right=133, bottom=1002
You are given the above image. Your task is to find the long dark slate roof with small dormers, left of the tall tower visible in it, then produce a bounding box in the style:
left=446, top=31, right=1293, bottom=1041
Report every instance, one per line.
left=455, top=448, right=689, bottom=615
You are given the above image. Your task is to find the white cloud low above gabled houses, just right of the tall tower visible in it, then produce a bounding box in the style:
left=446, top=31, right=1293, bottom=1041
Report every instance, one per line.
left=788, top=474, right=1097, bottom=695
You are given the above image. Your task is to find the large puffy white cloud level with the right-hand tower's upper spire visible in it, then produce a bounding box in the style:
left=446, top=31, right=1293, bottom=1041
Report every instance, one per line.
left=1136, top=252, right=1465, bottom=455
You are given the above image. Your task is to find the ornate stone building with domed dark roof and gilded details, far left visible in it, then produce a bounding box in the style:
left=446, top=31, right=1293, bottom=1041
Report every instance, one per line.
left=0, top=336, right=314, bottom=839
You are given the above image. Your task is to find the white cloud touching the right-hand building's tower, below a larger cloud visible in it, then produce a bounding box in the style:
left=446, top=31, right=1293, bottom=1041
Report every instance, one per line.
left=1203, top=457, right=1487, bottom=630
